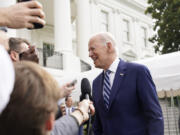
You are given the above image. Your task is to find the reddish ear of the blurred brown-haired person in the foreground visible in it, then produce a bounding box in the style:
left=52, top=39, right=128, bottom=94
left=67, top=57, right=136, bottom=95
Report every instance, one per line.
left=45, top=113, right=55, bottom=131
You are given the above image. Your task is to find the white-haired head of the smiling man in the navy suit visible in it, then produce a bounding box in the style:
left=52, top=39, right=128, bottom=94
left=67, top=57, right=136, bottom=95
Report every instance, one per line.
left=88, top=32, right=117, bottom=70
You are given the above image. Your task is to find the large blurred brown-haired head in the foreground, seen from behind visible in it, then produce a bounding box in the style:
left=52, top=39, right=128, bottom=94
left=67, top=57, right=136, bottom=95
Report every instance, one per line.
left=0, top=61, right=60, bottom=135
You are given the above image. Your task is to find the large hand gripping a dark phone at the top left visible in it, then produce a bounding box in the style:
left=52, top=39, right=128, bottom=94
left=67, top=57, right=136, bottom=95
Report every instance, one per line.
left=0, top=0, right=45, bottom=29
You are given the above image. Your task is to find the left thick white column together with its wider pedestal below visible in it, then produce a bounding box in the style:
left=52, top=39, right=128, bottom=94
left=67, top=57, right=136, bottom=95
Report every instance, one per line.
left=54, top=0, right=80, bottom=72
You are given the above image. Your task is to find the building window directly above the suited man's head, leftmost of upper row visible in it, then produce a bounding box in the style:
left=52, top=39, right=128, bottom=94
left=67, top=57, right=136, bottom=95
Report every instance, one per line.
left=101, top=11, right=108, bottom=32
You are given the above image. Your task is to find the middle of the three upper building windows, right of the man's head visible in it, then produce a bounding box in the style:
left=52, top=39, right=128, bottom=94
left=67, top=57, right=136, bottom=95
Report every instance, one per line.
left=123, top=20, right=130, bottom=42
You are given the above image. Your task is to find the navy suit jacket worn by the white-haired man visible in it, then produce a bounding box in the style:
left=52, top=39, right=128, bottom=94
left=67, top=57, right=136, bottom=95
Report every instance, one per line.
left=93, top=60, right=164, bottom=135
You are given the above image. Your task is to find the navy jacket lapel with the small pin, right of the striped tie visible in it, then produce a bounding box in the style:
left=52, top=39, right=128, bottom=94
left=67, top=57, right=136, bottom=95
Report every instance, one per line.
left=109, top=60, right=126, bottom=110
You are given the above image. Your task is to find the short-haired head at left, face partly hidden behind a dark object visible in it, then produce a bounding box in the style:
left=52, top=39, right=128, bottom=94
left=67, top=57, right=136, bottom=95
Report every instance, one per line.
left=9, top=38, right=29, bottom=62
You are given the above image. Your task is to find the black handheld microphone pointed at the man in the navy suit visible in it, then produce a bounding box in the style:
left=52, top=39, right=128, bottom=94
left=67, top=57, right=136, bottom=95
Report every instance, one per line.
left=80, top=78, right=92, bottom=101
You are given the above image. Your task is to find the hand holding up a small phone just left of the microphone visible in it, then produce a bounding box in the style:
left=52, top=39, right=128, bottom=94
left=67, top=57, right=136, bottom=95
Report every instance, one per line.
left=60, top=83, right=75, bottom=98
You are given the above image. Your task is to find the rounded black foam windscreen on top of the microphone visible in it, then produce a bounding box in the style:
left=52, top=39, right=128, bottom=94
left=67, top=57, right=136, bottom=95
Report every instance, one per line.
left=81, top=78, right=91, bottom=95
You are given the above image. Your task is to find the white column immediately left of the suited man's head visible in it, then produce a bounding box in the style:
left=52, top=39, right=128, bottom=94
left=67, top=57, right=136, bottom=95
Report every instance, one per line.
left=77, top=0, right=91, bottom=61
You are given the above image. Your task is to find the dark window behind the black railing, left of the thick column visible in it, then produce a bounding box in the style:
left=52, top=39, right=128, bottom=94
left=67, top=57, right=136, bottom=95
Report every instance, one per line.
left=43, top=43, right=54, bottom=67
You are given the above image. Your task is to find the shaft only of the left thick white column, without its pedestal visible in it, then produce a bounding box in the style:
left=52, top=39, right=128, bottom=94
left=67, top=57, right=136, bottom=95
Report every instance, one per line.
left=54, top=0, right=72, bottom=52
